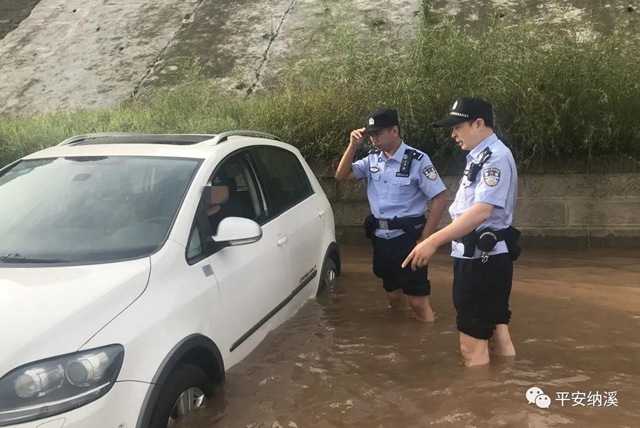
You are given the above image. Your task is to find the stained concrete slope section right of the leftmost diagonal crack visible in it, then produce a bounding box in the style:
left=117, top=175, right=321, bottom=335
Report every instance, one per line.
left=134, top=0, right=422, bottom=95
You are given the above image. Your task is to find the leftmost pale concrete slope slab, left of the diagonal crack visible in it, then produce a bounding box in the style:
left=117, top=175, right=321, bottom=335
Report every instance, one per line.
left=0, top=0, right=198, bottom=114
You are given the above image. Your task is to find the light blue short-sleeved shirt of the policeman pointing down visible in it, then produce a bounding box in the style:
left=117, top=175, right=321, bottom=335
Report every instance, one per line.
left=449, top=134, right=518, bottom=259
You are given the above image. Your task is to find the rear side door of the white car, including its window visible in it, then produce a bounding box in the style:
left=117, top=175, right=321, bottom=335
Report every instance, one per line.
left=246, top=146, right=327, bottom=294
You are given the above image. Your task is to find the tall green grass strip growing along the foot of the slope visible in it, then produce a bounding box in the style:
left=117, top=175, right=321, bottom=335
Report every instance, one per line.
left=0, top=4, right=640, bottom=172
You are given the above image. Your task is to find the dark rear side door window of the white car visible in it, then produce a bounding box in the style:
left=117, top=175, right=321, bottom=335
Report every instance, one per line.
left=252, top=147, right=313, bottom=221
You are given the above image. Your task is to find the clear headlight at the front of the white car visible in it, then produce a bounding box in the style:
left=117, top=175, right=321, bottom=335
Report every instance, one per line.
left=0, top=345, right=124, bottom=427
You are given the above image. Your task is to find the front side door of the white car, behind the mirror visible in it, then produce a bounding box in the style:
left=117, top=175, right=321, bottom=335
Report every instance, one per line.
left=189, top=151, right=290, bottom=354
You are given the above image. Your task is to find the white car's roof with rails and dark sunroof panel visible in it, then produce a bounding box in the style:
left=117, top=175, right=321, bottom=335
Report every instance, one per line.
left=18, top=130, right=292, bottom=159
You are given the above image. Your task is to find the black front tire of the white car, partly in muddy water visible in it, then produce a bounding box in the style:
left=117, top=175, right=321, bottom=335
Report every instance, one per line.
left=148, top=364, right=213, bottom=428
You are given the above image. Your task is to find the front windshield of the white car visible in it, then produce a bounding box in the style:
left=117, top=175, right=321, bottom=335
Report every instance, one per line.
left=0, top=156, right=200, bottom=267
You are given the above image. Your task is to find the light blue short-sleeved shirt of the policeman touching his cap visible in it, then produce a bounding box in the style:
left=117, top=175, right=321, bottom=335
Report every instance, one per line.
left=352, top=141, right=446, bottom=239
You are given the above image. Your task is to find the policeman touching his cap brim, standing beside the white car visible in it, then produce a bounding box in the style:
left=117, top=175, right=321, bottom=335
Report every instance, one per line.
left=335, top=109, right=446, bottom=322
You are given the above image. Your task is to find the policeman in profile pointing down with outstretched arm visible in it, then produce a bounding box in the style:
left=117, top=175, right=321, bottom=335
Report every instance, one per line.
left=402, top=98, right=520, bottom=366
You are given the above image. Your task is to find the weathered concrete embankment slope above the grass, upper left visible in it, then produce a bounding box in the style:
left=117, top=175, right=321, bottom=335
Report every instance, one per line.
left=0, top=0, right=422, bottom=115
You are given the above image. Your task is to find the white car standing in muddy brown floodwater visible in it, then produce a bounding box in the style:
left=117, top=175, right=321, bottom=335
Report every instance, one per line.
left=0, top=131, right=340, bottom=428
